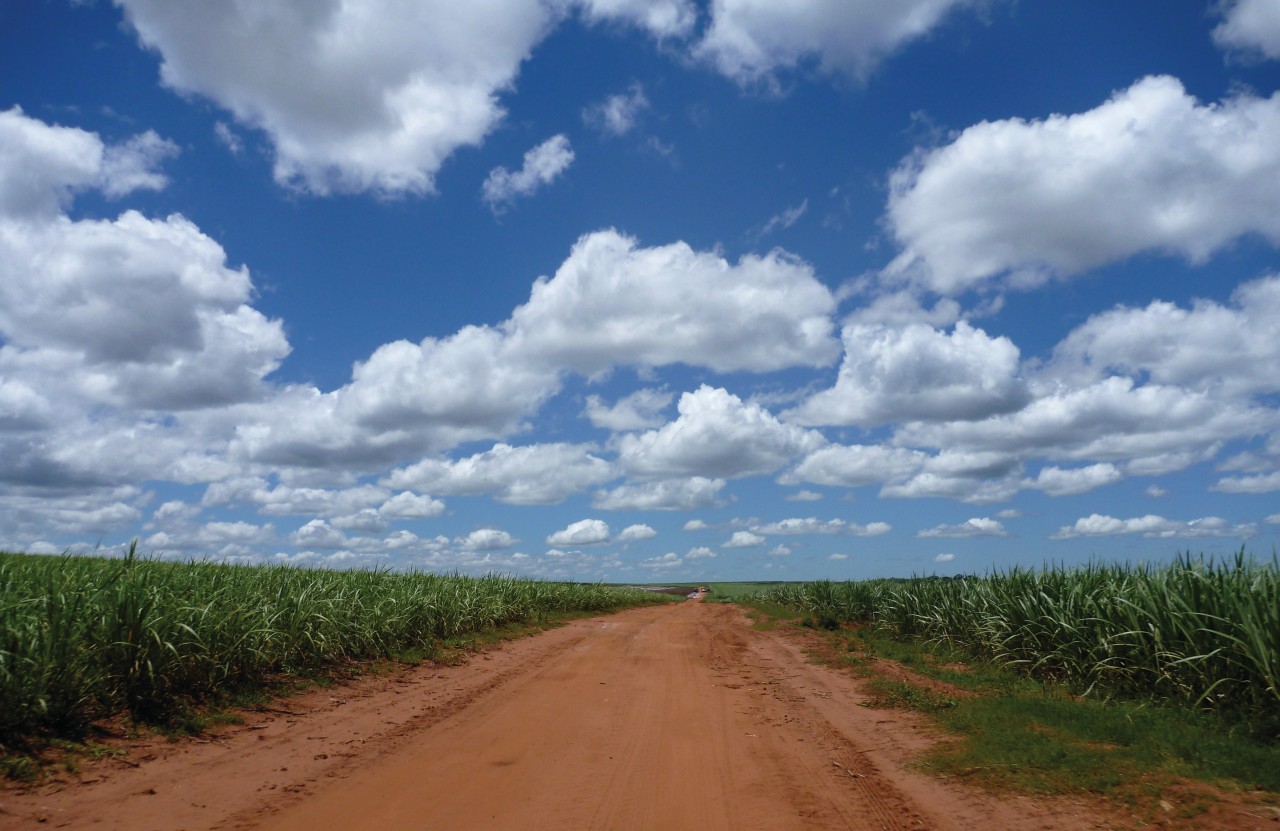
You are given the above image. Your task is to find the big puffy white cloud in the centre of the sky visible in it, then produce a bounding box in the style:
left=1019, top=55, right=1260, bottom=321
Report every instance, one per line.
left=504, top=230, right=838, bottom=375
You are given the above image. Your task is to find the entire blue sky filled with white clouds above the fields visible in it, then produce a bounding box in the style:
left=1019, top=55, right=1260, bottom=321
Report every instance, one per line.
left=0, top=0, right=1280, bottom=583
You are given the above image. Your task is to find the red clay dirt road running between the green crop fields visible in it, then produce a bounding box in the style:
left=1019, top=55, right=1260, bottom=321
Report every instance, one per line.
left=0, top=603, right=1277, bottom=831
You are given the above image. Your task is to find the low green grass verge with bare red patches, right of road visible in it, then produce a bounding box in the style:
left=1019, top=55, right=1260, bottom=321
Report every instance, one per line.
left=744, top=599, right=1280, bottom=808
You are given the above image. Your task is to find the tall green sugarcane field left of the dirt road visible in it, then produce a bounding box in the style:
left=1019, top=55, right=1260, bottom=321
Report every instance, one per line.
left=0, top=552, right=658, bottom=748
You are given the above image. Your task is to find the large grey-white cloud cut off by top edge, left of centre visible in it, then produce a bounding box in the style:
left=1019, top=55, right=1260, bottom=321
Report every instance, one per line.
left=120, top=0, right=557, bottom=195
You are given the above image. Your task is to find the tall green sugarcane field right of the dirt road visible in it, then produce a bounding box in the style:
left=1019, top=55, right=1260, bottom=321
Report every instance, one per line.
left=763, top=551, right=1280, bottom=738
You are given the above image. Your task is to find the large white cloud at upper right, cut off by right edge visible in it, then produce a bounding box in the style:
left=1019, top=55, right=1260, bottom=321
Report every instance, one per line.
left=886, top=77, right=1280, bottom=294
